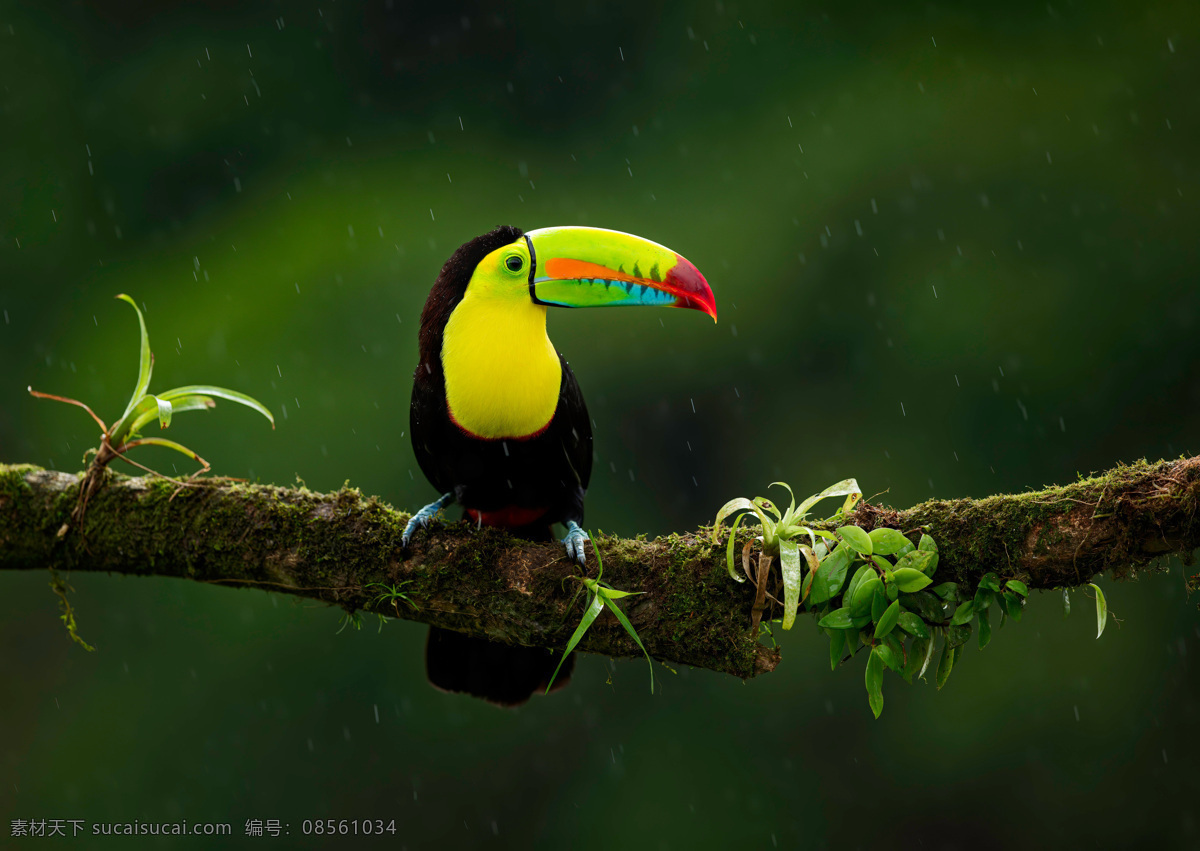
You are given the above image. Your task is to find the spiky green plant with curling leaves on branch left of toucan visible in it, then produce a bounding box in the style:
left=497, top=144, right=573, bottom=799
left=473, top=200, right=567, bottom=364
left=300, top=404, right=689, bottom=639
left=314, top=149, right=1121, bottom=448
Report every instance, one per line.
left=29, top=293, right=275, bottom=535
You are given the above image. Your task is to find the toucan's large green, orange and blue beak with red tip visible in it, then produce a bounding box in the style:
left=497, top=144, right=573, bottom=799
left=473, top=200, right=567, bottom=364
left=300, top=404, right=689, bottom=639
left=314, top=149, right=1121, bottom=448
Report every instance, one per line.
left=524, top=227, right=716, bottom=322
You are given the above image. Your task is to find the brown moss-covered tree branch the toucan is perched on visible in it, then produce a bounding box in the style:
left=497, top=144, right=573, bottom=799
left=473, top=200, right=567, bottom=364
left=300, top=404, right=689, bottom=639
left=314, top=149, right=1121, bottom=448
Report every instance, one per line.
left=0, top=457, right=1200, bottom=677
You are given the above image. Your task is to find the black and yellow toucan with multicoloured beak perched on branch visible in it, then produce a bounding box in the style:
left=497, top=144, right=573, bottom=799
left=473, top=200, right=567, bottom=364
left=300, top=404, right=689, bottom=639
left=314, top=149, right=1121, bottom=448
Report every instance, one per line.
left=402, top=226, right=716, bottom=706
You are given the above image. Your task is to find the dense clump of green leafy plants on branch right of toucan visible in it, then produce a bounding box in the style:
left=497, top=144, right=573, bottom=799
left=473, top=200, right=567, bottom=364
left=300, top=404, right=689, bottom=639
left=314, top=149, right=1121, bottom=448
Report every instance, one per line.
left=713, top=479, right=1108, bottom=718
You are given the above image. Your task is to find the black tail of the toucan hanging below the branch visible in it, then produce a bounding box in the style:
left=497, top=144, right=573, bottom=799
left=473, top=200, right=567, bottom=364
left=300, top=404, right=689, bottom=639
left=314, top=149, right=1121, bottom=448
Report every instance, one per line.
left=425, top=627, right=575, bottom=706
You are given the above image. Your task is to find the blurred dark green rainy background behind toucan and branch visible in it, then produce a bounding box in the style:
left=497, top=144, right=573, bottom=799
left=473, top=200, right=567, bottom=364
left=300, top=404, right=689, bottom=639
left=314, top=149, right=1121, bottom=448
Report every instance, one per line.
left=0, top=0, right=1200, bottom=849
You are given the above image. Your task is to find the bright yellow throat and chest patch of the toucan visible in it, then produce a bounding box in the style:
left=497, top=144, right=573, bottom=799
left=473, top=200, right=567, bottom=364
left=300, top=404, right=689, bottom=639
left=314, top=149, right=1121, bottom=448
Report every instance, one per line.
left=442, top=250, right=563, bottom=439
